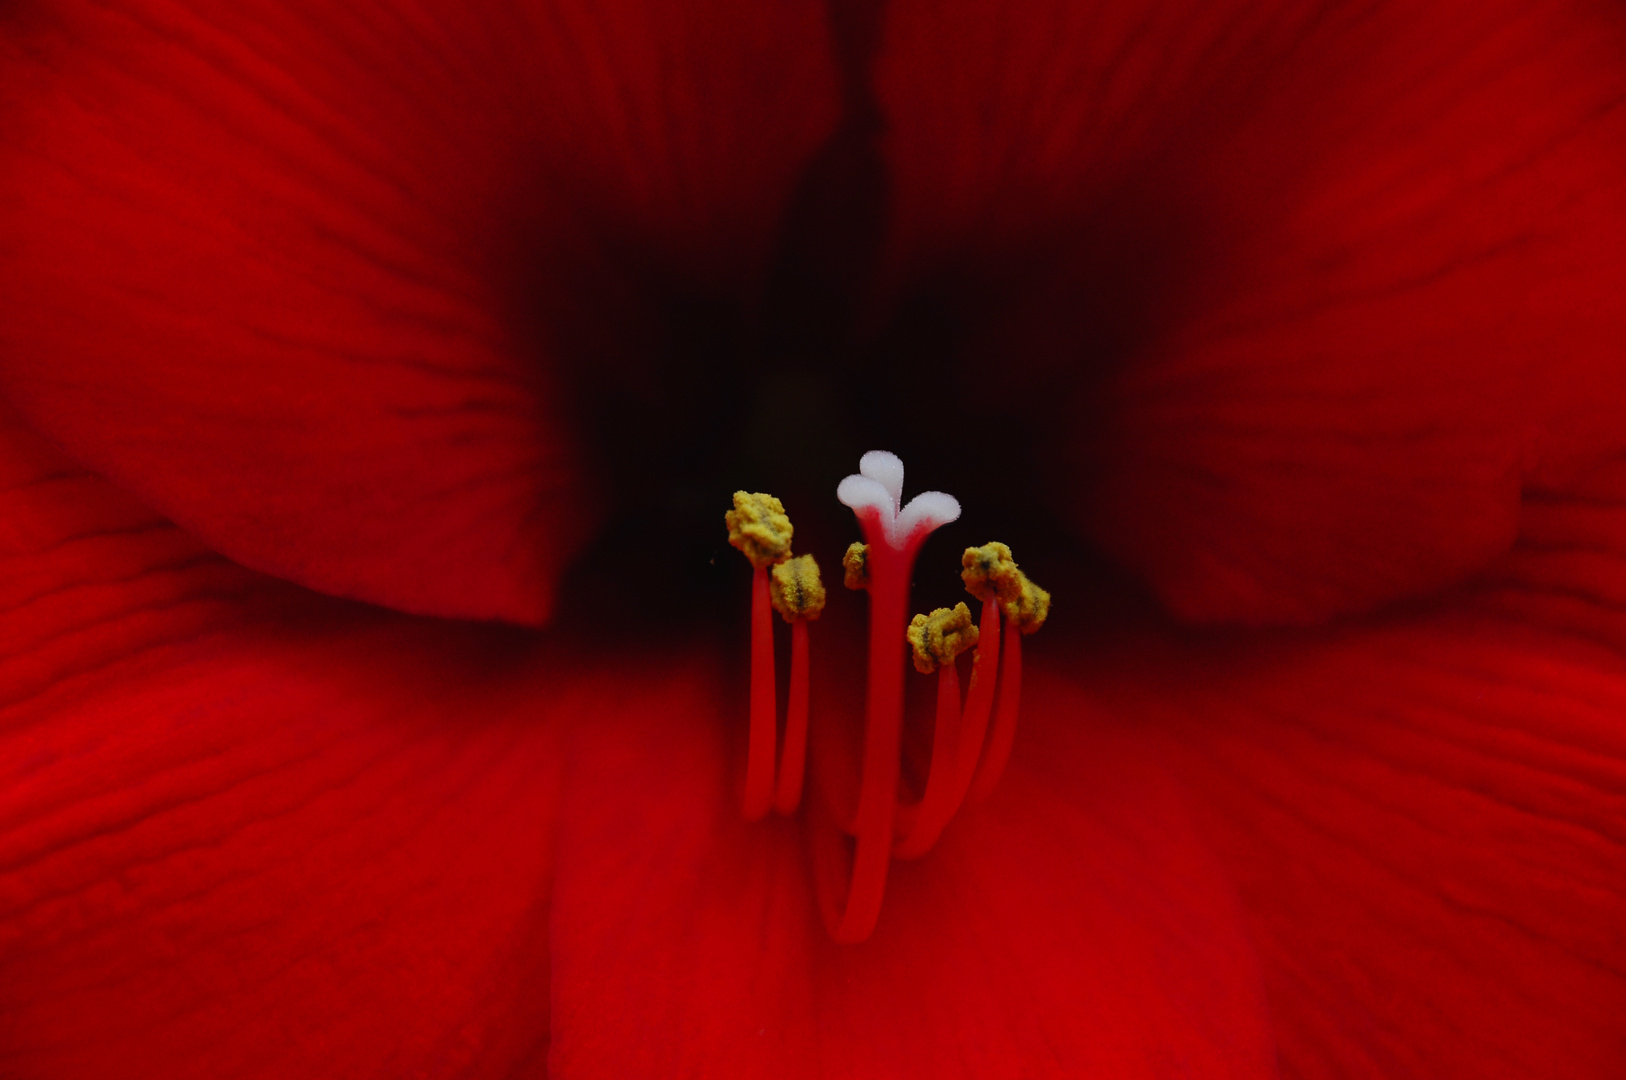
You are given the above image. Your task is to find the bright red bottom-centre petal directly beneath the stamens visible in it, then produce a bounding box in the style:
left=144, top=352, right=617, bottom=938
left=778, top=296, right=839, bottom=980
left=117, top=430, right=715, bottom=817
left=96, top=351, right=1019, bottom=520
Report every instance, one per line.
left=551, top=662, right=1275, bottom=1078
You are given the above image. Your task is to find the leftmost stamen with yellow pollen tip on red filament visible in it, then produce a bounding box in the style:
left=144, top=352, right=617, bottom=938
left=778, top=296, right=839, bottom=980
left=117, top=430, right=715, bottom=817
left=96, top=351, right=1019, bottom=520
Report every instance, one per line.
left=724, top=491, right=795, bottom=821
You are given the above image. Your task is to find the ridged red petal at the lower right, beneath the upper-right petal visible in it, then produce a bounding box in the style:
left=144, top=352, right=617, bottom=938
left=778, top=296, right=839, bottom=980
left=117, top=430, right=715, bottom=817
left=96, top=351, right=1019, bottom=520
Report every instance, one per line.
left=1081, top=462, right=1626, bottom=1080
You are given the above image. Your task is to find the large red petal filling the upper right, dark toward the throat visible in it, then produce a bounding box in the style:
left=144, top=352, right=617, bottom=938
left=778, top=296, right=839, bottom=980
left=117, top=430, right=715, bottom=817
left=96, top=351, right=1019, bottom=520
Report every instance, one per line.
left=881, top=0, right=1626, bottom=621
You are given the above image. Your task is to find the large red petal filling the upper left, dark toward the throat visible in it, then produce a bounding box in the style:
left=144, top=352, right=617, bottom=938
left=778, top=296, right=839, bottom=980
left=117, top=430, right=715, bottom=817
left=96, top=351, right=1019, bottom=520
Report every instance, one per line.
left=0, top=0, right=836, bottom=623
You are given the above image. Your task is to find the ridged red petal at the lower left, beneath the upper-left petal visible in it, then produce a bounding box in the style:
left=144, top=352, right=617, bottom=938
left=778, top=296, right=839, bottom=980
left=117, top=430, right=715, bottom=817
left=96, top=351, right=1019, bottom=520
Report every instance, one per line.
left=0, top=409, right=569, bottom=1080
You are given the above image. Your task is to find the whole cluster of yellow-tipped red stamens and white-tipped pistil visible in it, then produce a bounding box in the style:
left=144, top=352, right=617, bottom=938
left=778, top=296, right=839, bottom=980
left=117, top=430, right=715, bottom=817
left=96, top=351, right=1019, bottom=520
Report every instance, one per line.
left=725, top=451, right=1050, bottom=942
